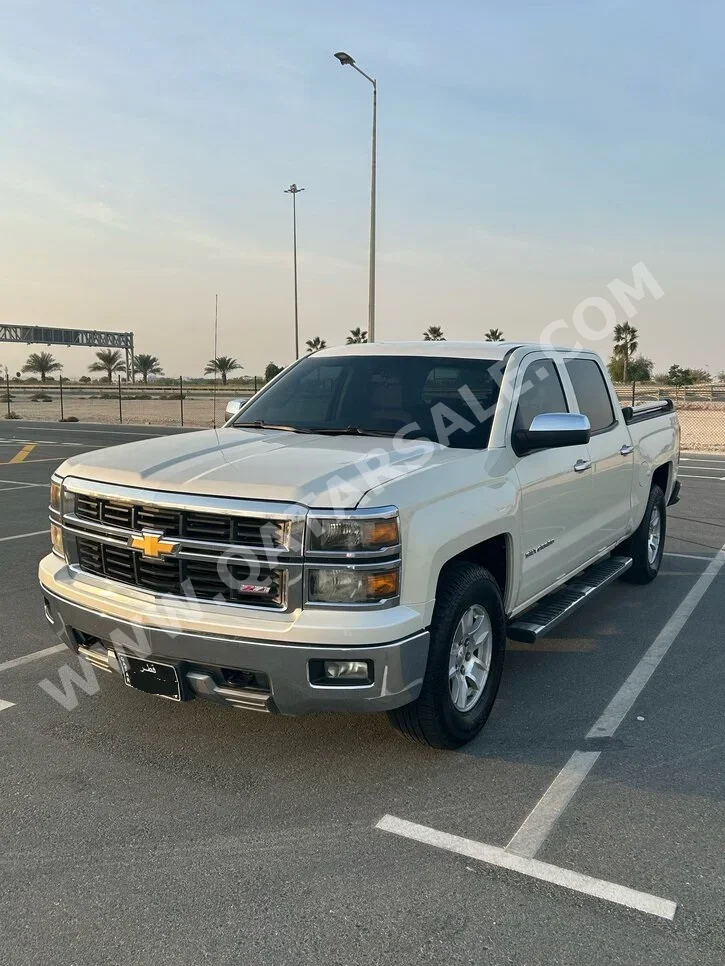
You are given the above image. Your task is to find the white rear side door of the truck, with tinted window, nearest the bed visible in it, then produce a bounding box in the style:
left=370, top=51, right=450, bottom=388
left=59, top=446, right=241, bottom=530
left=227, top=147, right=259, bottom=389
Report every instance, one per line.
left=564, top=356, right=634, bottom=556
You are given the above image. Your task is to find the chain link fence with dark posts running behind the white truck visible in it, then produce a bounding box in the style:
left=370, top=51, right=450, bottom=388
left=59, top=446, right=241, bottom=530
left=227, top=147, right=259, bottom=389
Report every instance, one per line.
left=0, top=379, right=725, bottom=452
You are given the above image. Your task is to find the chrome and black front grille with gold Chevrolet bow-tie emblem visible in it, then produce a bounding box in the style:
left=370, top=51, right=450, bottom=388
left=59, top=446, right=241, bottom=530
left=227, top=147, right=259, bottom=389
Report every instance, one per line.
left=63, top=479, right=306, bottom=611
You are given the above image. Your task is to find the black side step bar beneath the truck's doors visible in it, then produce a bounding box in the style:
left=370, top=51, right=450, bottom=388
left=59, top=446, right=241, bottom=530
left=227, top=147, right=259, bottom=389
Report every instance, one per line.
left=508, top=557, right=632, bottom=644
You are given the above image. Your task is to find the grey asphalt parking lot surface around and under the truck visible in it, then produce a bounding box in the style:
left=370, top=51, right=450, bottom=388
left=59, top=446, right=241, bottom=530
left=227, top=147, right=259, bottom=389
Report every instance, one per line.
left=0, top=423, right=725, bottom=966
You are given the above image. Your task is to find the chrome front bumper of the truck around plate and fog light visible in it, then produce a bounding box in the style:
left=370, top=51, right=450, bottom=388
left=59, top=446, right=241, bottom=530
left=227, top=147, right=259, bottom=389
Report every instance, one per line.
left=41, top=585, right=429, bottom=714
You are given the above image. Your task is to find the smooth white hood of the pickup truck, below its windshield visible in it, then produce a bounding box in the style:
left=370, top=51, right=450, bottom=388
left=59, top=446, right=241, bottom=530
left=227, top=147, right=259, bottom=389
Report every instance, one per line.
left=59, top=429, right=467, bottom=509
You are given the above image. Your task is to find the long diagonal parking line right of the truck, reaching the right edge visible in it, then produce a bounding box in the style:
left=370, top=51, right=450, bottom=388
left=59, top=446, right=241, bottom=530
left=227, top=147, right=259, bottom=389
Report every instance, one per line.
left=587, top=546, right=725, bottom=738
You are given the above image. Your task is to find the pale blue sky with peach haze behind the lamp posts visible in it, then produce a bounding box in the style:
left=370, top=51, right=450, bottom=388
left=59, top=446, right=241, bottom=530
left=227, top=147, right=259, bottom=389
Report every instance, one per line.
left=0, top=0, right=725, bottom=376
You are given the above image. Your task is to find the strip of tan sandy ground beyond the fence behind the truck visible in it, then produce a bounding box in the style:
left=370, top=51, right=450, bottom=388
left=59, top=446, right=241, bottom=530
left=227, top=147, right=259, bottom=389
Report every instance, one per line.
left=3, top=393, right=725, bottom=452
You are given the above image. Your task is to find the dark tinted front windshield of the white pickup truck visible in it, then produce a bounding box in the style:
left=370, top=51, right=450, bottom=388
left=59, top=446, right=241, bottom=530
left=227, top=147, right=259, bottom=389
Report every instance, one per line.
left=232, top=355, right=503, bottom=449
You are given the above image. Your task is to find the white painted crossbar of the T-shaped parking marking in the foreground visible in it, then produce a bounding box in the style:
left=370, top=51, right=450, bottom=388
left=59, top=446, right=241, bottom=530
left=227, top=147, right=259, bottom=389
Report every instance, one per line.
left=376, top=815, right=677, bottom=921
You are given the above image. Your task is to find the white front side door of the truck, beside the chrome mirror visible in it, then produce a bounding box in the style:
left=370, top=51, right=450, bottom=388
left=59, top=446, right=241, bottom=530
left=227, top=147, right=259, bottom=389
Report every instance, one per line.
left=508, top=355, right=592, bottom=607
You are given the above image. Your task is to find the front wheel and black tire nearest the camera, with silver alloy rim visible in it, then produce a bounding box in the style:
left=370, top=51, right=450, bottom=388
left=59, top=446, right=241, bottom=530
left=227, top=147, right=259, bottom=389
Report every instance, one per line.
left=388, top=563, right=506, bottom=748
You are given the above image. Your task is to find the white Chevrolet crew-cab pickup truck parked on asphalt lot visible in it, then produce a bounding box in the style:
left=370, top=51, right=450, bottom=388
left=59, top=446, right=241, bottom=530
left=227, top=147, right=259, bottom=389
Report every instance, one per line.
left=39, top=342, right=679, bottom=748
